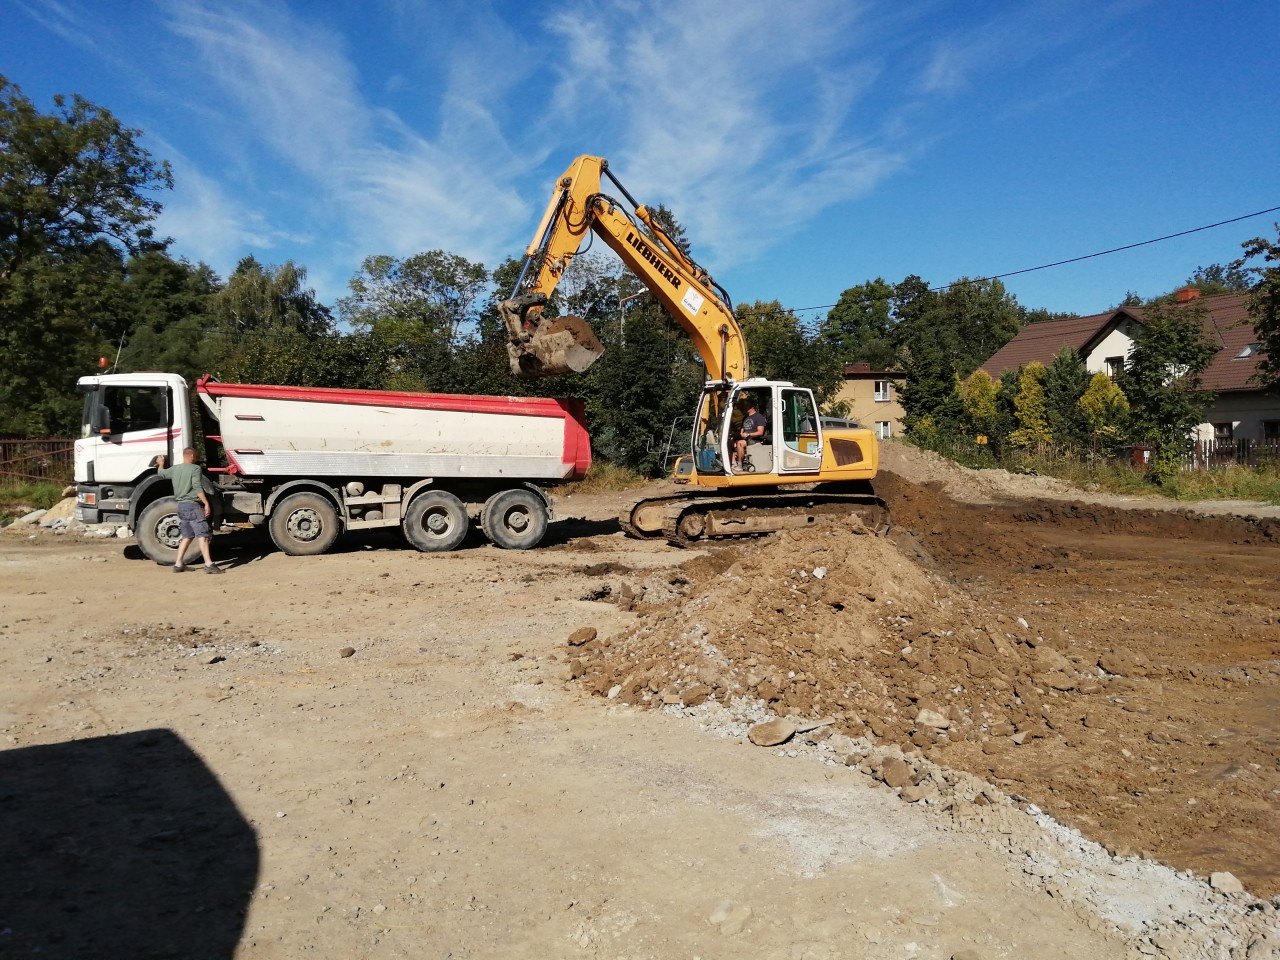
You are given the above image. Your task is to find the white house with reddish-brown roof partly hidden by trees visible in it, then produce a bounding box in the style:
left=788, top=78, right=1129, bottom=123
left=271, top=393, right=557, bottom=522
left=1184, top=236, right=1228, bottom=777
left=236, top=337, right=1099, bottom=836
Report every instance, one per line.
left=980, top=289, right=1280, bottom=442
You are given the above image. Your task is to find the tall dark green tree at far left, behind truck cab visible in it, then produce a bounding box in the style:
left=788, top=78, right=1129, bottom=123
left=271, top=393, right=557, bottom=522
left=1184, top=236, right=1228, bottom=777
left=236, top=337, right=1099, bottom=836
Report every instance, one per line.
left=0, top=77, right=173, bottom=433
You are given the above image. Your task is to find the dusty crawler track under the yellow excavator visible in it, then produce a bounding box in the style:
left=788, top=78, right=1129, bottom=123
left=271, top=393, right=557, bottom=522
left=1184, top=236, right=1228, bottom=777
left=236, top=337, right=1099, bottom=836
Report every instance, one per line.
left=618, top=489, right=890, bottom=547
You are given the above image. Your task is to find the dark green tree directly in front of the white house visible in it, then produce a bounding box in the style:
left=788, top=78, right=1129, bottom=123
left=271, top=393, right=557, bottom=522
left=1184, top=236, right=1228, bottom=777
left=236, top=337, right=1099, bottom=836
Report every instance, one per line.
left=1117, top=300, right=1217, bottom=483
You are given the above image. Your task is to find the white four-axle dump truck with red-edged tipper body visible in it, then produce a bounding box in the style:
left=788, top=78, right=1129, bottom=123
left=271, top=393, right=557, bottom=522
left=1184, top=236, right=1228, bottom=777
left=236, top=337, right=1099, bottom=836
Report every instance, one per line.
left=76, top=372, right=591, bottom=564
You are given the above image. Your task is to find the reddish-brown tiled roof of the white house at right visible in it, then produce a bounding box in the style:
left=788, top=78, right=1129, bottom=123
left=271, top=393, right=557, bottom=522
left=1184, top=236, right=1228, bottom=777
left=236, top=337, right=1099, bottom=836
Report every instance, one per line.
left=982, top=293, right=1260, bottom=393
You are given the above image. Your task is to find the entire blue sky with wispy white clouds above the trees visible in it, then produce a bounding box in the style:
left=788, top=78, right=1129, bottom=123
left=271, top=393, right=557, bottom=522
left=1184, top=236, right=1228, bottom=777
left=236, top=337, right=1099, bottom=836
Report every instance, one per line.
left=0, top=0, right=1280, bottom=317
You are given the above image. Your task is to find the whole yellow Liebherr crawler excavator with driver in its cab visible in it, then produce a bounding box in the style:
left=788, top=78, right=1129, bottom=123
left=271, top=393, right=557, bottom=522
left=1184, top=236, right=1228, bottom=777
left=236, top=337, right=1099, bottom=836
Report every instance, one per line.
left=499, top=156, right=888, bottom=547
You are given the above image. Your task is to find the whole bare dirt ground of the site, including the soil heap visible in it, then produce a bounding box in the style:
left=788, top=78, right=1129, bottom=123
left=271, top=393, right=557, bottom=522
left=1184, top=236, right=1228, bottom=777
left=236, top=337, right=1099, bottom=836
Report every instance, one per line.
left=0, top=445, right=1280, bottom=960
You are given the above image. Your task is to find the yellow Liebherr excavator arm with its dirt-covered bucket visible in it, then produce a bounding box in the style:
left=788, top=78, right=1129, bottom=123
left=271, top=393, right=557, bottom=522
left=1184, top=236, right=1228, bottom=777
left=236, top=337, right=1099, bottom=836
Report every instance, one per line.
left=498, top=156, right=749, bottom=384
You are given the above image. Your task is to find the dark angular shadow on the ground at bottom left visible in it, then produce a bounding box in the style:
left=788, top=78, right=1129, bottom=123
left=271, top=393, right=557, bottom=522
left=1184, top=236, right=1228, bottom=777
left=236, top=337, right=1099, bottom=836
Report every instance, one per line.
left=0, top=730, right=259, bottom=960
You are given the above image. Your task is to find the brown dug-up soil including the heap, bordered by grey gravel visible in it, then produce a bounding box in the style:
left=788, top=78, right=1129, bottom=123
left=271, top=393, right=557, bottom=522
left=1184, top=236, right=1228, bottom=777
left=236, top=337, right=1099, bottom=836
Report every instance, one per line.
left=566, top=474, right=1280, bottom=895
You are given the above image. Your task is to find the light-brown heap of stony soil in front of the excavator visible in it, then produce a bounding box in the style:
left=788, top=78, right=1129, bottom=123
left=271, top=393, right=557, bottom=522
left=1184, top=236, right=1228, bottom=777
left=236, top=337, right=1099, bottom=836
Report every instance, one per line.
left=573, top=512, right=1101, bottom=750
